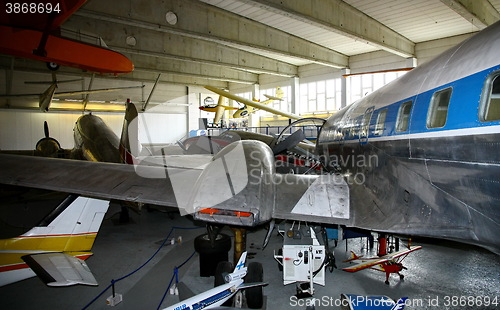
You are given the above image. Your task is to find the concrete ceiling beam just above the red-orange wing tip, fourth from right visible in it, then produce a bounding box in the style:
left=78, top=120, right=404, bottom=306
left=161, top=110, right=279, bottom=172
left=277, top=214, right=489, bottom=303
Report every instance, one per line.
left=64, top=13, right=298, bottom=77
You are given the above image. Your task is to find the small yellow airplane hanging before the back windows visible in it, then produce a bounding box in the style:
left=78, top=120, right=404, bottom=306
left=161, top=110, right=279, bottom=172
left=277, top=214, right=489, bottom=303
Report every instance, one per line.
left=200, top=86, right=301, bottom=123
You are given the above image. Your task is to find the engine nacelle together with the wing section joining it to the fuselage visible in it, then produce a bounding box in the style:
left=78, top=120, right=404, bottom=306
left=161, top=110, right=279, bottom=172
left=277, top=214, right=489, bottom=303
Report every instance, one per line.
left=189, top=140, right=352, bottom=226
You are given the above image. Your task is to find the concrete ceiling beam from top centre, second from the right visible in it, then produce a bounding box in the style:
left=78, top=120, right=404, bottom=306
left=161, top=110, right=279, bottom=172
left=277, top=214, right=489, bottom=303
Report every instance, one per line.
left=239, top=0, right=415, bottom=58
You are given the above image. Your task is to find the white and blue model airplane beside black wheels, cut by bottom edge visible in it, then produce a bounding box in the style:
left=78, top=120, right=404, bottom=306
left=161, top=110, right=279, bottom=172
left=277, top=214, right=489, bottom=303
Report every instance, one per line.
left=163, top=252, right=267, bottom=310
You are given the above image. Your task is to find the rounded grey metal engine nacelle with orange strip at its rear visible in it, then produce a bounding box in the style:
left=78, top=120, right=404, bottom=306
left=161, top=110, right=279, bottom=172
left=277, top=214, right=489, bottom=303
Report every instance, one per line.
left=191, top=140, right=276, bottom=226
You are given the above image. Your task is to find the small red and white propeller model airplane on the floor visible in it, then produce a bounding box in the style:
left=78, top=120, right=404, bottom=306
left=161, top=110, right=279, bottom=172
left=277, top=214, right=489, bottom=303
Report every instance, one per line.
left=342, top=246, right=422, bottom=284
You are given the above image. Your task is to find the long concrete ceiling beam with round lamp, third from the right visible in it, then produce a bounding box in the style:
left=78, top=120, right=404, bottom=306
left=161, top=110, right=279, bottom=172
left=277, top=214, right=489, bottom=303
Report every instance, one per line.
left=75, top=0, right=348, bottom=68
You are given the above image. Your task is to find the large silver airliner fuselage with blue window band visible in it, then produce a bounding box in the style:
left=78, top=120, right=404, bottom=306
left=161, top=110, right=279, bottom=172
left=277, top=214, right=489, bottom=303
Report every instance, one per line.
left=317, top=23, right=500, bottom=250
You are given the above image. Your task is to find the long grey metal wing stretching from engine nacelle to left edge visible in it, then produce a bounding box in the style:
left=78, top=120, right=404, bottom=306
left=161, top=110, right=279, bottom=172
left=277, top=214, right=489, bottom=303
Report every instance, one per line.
left=0, top=154, right=183, bottom=206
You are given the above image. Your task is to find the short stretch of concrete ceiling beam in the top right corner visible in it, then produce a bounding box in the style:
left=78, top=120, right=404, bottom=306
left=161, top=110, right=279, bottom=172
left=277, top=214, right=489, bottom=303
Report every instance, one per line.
left=441, top=0, right=500, bottom=30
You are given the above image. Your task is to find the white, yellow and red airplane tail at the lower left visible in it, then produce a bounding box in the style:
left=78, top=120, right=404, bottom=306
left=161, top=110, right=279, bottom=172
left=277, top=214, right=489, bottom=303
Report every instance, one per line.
left=0, top=195, right=109, bottom=286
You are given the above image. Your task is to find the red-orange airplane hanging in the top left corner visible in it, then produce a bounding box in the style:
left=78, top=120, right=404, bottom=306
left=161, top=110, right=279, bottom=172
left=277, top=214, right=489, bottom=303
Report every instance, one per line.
left=0, top=0, right=134, bottom=75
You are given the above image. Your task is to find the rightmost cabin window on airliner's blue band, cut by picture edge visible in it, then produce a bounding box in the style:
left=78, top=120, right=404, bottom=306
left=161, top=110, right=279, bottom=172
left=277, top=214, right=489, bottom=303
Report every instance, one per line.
left=480, top=71, right=500, bottom=122
